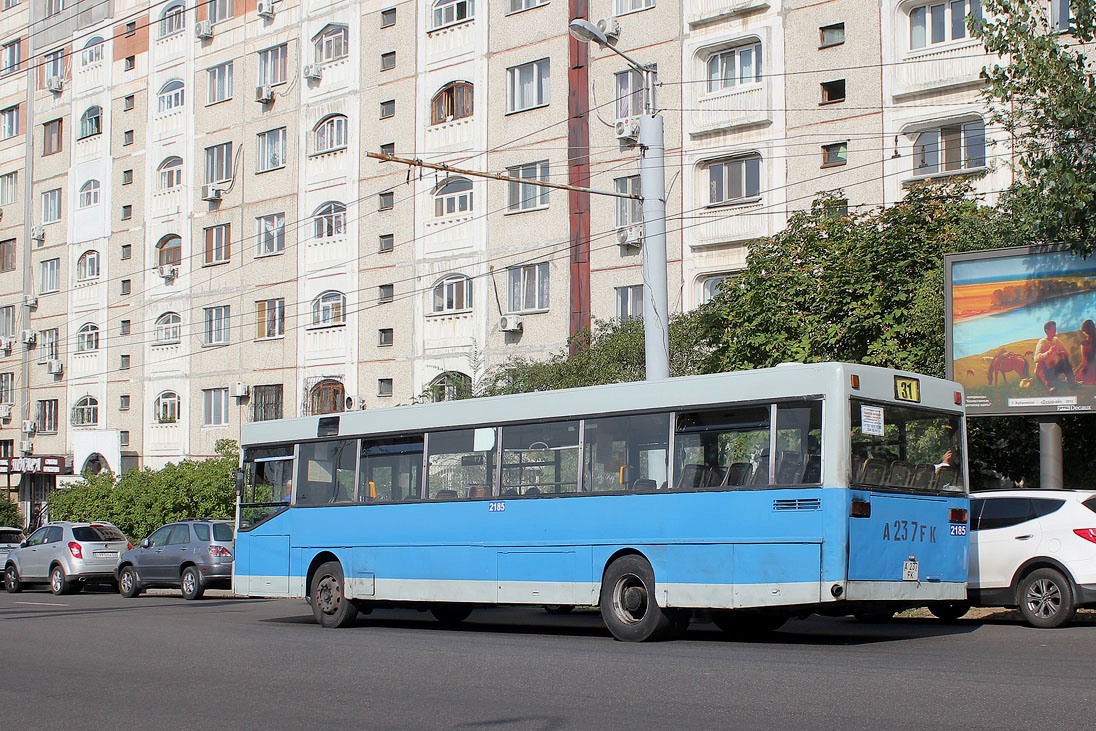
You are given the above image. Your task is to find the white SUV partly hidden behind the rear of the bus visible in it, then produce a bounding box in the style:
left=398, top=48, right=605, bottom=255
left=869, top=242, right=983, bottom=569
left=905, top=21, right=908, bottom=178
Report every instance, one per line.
left=968, top=490, right=1096, bottom=627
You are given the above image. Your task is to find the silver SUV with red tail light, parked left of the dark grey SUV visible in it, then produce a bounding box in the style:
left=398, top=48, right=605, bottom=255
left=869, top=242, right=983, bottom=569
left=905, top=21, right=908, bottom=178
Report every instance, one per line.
left=3, top=522, right=130, bottom=594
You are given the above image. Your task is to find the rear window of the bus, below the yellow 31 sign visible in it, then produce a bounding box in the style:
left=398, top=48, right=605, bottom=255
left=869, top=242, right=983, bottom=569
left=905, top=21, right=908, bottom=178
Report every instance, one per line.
left=849, top=399, right=966, bottom=492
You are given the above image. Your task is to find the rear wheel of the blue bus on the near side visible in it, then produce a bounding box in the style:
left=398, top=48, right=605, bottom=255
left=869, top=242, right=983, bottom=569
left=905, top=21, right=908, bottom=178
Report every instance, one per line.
left=601, top=555, right=674, bottom=642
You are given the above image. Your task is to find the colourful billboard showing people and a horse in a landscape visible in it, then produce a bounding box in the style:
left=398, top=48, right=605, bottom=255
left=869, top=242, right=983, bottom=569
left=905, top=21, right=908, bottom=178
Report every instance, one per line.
left=944, top=247, right=1096, bottom=416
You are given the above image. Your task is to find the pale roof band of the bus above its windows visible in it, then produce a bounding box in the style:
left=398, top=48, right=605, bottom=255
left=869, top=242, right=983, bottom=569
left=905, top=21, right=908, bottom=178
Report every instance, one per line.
left=241, top=363, right=962, bottom=446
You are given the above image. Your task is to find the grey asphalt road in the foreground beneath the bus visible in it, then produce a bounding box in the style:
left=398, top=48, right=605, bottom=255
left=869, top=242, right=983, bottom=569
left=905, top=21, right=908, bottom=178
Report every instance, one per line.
left=0, top=591, right=1096, bottom=731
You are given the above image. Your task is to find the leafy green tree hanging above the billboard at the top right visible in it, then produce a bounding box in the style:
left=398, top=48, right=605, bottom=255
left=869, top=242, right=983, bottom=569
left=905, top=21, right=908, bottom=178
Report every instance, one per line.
left=970, top=0, right=1096, bottom=255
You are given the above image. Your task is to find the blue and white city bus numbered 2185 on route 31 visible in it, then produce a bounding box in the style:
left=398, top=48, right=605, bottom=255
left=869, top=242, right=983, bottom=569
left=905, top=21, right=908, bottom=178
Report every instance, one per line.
left=233, top=363, right=969, bottom=641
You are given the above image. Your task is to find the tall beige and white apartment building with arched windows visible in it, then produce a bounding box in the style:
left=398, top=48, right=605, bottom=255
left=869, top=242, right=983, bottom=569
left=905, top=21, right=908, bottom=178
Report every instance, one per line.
left=0, top=0, right=1011, bottom=523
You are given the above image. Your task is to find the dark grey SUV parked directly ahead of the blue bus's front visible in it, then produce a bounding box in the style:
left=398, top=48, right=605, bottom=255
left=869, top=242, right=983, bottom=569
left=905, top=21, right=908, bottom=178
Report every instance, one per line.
left=116, top=521, right=233, bottom=599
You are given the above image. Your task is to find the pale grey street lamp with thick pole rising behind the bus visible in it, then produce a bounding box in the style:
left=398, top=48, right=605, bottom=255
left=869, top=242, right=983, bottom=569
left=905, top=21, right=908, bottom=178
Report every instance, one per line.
left=568, top=18, right=670, bottom=380
